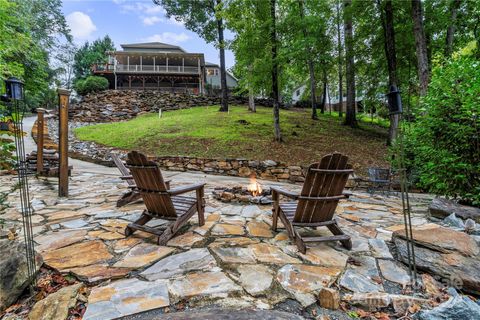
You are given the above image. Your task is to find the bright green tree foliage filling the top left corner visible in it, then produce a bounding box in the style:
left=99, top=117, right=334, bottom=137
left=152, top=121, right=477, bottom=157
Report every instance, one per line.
left=0, top=0, right=71, bottom=109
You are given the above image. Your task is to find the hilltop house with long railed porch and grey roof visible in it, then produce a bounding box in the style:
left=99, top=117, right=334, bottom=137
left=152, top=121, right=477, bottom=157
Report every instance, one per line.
left=92, top=42, right=205, bottom=94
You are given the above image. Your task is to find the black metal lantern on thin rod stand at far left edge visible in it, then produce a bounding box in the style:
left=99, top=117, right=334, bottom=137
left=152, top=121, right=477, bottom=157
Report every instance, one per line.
left=1, top=77, right=36, bottom=281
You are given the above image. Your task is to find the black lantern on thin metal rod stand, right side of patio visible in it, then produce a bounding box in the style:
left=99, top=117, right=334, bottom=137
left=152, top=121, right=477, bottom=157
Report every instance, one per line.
left=387, top=85, right=417, bottom=288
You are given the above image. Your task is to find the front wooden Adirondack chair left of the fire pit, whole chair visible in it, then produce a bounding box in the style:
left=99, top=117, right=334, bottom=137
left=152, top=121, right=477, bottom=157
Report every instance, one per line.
left=125, top=151, right=205, bottom=245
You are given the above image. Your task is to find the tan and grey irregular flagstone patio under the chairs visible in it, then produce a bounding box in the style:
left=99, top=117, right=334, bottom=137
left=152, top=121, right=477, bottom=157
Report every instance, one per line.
left=0, top=172, right=438, bottom=319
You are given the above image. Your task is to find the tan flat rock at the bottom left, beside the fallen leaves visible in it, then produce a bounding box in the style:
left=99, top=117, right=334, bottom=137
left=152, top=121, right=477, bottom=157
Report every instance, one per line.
left=28, top=283, right=84, bottom=320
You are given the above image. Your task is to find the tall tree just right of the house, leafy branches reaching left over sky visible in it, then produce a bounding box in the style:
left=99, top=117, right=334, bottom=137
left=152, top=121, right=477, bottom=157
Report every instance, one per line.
left=153, top=0, right=228, bottom=112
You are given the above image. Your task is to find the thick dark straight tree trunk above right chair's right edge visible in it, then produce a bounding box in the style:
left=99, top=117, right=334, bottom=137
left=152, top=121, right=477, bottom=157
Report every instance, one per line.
left=343, top=0, right=358, bottom=128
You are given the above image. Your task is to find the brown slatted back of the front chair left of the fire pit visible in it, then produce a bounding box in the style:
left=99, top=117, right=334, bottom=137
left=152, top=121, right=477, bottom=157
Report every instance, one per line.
left=127, top=151, right=177, bottom=218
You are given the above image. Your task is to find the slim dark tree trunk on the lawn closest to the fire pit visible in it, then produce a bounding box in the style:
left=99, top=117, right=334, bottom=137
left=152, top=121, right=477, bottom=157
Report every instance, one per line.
left=270, top=0, right=282, bottom=142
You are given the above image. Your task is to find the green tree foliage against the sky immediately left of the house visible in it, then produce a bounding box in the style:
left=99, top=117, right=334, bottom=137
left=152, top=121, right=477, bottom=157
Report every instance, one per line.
left=73, top=35, right=115, bottom=80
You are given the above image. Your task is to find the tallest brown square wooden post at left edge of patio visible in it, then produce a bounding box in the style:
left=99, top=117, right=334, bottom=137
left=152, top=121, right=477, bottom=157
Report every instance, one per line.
left=57, top=89, right=70, bottom=197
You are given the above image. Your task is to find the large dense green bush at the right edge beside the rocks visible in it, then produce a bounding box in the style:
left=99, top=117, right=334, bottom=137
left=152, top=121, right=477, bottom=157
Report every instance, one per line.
left=406, top=56, right=480, bottom=206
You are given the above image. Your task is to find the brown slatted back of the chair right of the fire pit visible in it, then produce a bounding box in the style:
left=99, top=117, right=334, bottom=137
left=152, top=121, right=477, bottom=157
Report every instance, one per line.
left=293, top=152, right=353, bottom=223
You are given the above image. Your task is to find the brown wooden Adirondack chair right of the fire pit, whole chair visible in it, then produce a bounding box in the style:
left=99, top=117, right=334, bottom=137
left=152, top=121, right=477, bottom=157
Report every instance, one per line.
left=271, top=153, right=353, bottom=253
